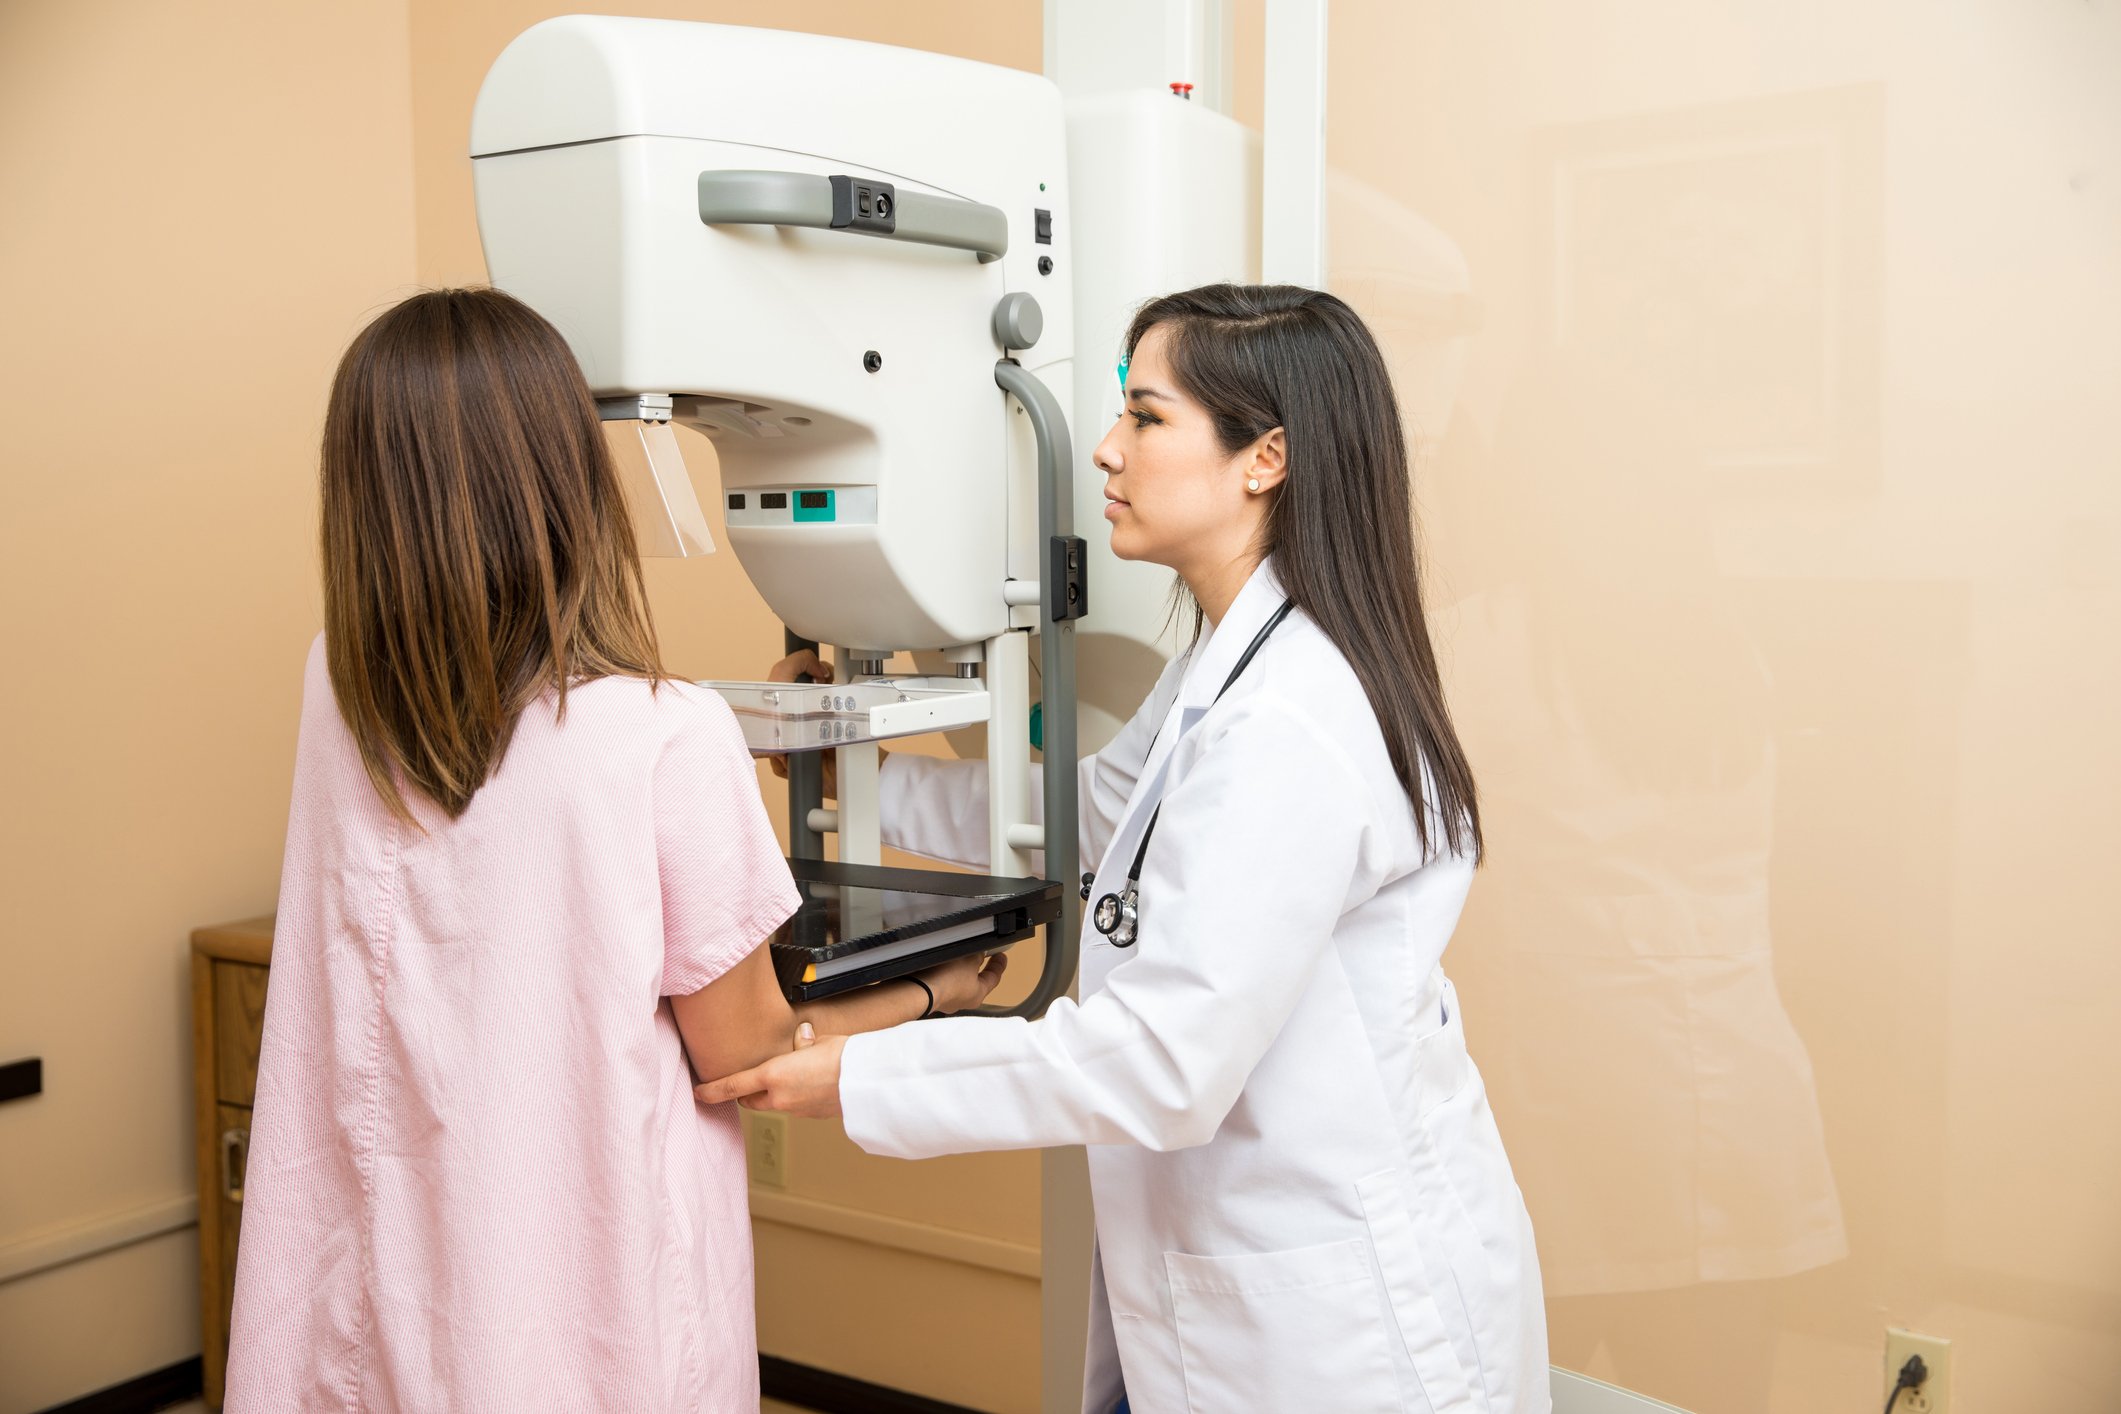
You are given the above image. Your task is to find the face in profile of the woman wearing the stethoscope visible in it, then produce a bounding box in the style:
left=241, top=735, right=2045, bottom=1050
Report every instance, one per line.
left=1092, top=324, right=1245, bottom=572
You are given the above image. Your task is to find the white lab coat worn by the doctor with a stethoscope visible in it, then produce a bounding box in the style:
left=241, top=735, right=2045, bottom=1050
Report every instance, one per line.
left=840, top=564, right=1550, bottom=1414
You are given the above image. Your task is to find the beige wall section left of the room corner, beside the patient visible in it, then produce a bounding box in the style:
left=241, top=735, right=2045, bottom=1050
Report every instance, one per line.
left=0, top=0, right=414, bottom=1410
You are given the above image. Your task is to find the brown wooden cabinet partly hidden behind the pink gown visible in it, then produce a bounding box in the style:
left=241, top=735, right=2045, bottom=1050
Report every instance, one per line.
left=191, top=918, right=271, bottom=1408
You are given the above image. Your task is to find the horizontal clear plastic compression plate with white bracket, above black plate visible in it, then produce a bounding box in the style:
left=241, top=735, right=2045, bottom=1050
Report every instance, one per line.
left=700, top=678, right=988, bottom=757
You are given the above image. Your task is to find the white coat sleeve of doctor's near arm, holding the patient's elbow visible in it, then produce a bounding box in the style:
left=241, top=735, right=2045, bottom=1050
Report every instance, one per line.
left=840, top=695, right=1389, bottom=1157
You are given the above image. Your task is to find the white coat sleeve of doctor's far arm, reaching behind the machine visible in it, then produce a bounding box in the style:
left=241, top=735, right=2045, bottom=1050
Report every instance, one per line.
left=876, top=674, right=1175, bottom=873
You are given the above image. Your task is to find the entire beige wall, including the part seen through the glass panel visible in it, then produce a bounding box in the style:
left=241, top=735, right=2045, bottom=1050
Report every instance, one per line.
left=12, top=0, right=2121, bottom=1414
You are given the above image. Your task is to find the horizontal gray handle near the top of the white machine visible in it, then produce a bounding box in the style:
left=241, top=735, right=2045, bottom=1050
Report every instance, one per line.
left=700, top=172, right=1010, bottom=265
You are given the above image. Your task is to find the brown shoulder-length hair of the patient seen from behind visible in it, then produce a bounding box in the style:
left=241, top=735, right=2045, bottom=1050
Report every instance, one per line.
left=322, top=290, right=662, bottom=820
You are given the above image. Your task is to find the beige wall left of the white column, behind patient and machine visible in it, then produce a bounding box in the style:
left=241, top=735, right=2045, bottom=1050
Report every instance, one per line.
left=0, top=0, right=1039, bottom=1414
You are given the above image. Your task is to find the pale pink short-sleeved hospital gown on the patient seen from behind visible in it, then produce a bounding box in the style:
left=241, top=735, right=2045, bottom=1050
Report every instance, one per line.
left=227, top=638, right=797, bottom=1414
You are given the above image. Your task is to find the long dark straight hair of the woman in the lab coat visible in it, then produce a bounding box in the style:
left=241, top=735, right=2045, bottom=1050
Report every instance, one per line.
left=1126, top=284, right=1480, bottom=859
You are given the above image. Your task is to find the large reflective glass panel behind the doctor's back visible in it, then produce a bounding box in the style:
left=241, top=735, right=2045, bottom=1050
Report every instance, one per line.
left=1328, top=0, right=2121, bottom=1414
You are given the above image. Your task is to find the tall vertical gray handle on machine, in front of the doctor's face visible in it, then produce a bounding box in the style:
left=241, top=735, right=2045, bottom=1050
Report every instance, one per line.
left=993, top=358, right=1084, bottom=1015
